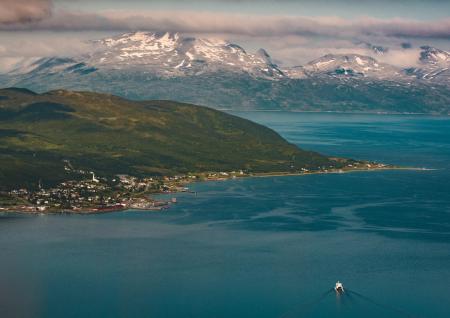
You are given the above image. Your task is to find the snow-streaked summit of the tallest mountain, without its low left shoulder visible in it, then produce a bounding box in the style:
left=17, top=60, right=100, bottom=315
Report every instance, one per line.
left=87, top=32, right=283, bottom=78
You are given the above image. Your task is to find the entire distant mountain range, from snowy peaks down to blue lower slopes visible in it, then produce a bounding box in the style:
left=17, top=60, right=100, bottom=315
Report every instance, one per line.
left=0, top=32, right=450, bottom=114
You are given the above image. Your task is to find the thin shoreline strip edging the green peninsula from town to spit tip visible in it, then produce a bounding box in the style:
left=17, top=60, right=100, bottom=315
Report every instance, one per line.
left=0, top=166, right=432, bottom=216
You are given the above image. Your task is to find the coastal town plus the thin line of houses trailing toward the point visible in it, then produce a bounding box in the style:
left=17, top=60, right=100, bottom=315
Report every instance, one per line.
left=0, top=161, right=394, bottom=214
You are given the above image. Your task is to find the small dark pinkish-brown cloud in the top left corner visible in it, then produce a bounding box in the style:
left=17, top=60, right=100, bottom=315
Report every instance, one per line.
left=0, top=0, right=53, bottom=26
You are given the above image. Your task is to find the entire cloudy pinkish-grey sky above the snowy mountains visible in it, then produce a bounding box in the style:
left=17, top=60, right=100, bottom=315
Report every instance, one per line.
left=0, top=0, right=450, bottom=66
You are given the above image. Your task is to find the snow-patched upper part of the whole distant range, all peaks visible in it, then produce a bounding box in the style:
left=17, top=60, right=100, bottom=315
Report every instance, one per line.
left=0, top=32, right=450, bottom=84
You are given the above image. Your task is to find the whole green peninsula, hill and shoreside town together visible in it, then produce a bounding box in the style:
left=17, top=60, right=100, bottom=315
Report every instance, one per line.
left=0, top=88, right=392, bottom=213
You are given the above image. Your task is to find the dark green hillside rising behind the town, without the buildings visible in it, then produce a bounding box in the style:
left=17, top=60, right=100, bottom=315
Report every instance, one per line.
left=0, top=88, right=342, bottom=189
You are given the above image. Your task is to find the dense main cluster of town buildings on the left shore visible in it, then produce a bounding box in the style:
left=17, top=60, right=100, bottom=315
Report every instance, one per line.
left=0, top=172, right=195, bottom=214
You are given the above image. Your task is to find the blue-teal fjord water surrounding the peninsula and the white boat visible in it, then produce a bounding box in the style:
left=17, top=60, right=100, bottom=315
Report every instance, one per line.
left=0, top=112, right=450, bottom=318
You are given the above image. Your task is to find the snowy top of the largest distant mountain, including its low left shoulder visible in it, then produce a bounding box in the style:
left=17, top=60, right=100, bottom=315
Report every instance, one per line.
left=2, top=32, right=284, bottom=79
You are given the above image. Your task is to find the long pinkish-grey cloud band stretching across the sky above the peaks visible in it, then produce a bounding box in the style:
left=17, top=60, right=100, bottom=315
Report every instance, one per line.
left=0, top=7, right=450, bottom=39
